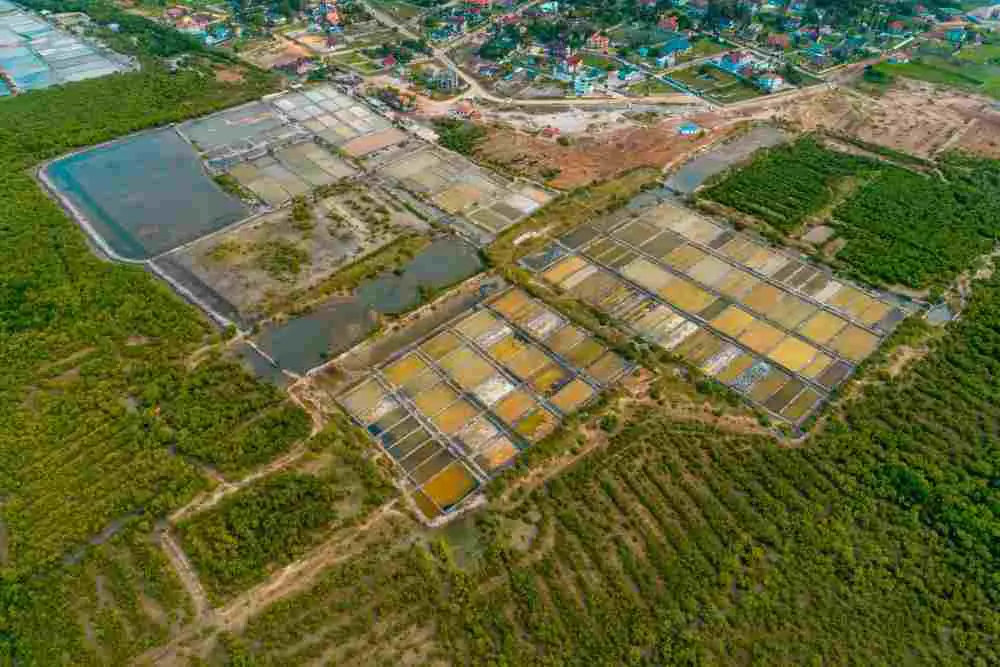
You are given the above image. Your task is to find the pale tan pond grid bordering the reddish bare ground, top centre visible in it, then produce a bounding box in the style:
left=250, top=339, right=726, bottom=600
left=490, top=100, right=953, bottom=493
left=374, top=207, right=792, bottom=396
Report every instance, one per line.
left=376, top=146, right=552, bottom=240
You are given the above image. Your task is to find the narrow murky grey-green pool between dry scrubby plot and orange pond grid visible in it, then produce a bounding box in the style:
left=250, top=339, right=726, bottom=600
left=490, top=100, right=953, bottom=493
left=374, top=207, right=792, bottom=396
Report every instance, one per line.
left=256, top=238, right=483, bottom=373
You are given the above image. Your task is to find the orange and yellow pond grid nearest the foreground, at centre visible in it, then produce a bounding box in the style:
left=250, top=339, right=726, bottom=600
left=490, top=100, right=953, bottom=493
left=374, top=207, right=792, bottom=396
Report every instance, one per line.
left=338, top=288, right=632, bottom=520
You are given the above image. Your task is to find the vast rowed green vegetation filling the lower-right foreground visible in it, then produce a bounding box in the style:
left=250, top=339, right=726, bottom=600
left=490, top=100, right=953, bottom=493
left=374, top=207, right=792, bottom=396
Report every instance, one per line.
left=213, top=279, right=1000, bottom=665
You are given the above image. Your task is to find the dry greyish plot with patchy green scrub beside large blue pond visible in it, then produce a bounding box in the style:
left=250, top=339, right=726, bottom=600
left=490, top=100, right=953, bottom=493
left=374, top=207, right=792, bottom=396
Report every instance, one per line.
left=164, top=180, right=426, bottom=321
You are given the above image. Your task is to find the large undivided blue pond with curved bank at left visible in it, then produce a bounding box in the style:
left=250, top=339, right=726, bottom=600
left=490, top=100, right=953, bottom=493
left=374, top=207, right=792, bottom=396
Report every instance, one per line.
left=45, top=128, right=249, bottom=260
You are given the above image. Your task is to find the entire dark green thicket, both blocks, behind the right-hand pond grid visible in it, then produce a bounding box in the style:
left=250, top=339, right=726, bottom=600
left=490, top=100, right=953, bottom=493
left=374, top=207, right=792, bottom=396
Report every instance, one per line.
left=703, top=137, right=1000, bottom=288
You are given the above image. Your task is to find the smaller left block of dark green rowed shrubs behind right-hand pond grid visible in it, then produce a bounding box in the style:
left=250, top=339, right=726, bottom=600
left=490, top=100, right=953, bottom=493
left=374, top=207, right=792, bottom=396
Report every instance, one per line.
left=703, top=137, right=875, bottom=233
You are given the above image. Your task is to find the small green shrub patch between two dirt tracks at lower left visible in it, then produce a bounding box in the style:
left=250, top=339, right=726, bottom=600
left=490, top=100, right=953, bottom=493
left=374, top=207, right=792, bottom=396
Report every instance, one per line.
left=177, top=423, right=394, bottom=599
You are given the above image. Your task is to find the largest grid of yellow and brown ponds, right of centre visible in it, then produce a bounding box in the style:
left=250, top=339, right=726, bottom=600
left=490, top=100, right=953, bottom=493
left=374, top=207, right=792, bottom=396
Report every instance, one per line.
left=523, top=202, right=905, bottom=425
